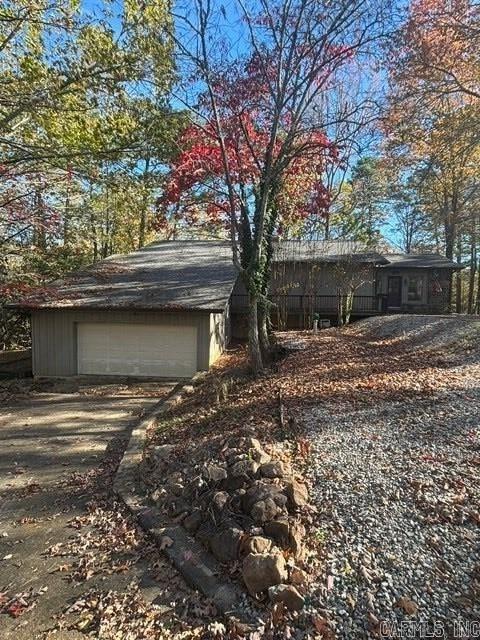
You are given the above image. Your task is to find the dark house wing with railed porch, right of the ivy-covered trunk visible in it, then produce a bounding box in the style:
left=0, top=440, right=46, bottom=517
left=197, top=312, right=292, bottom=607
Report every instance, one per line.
left=231, top=240, right=462, bottom=333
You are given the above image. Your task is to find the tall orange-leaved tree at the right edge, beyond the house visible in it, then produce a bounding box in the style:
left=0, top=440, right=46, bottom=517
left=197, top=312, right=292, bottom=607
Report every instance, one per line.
left=386, top=0, right=480, bottom=312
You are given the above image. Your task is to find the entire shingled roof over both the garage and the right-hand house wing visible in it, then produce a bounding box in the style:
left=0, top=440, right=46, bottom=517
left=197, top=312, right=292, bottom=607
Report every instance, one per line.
left=15, top=240, right=462, bottom=312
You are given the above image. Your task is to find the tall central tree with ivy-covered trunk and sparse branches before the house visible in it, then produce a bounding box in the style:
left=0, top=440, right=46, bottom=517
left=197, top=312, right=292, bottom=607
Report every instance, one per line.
left=167, top=0, right=392, bottom=371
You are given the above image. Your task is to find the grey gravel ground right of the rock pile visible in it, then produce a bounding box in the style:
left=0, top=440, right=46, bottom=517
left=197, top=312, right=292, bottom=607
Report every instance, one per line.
left=303, top=316, right=480, bottom=640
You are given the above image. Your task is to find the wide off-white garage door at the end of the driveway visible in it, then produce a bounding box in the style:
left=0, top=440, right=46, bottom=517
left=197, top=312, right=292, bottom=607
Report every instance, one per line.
left=77, top=322, right=197, bottom=378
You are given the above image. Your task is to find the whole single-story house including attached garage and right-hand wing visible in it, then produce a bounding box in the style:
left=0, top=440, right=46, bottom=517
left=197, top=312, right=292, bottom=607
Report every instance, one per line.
left=15, top=240, right=458, bottom=378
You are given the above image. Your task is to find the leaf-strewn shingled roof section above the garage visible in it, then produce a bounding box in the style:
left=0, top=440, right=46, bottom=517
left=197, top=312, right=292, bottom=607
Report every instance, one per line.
left=20, top=240, right=238, bottom=311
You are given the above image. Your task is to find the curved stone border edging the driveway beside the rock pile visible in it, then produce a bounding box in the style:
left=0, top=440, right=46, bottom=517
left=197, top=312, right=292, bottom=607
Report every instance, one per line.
left=113, top=372, right=254, bottom=624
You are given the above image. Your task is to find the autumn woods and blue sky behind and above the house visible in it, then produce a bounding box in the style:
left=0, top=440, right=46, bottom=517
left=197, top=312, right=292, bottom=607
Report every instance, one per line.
left=0, top=0, right=480, bottom=349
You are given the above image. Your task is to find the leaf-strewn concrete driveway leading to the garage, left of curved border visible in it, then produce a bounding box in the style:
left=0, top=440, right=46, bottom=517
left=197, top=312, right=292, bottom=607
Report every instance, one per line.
left=0, top=383, right=211, bottom=640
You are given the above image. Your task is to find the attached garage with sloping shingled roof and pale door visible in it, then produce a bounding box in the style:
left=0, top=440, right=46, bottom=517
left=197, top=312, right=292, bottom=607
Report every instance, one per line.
left=24, top=241, right=238, bottom=378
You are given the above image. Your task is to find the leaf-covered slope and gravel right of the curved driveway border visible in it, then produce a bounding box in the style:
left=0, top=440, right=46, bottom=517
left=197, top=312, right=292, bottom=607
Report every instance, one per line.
left=147, top=316, right=480, bottom=640
